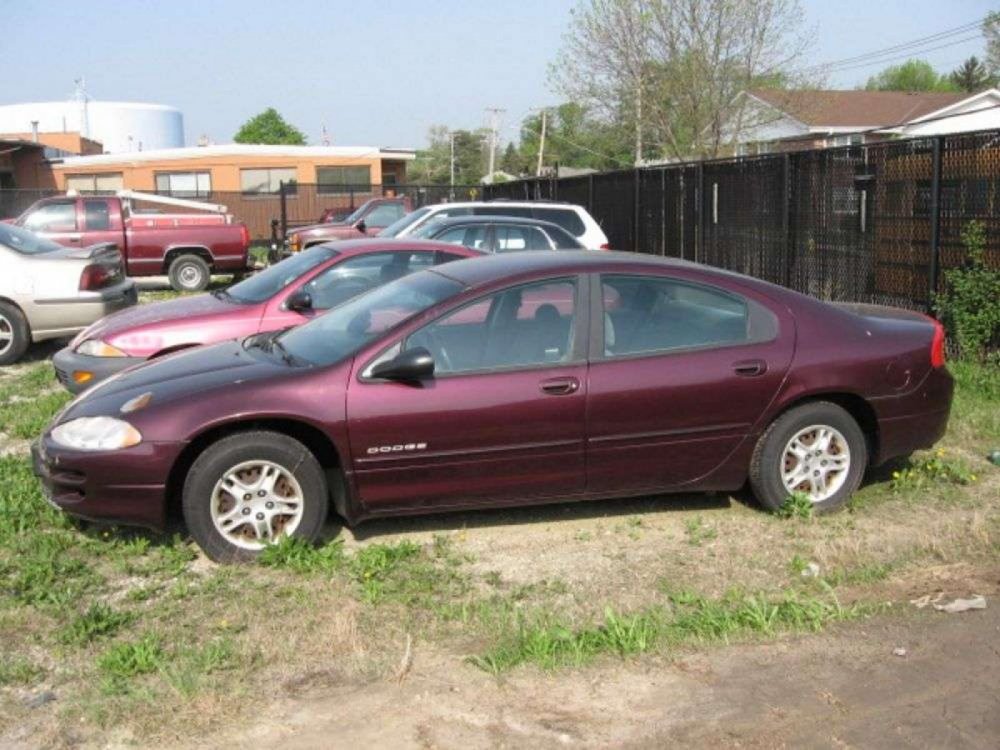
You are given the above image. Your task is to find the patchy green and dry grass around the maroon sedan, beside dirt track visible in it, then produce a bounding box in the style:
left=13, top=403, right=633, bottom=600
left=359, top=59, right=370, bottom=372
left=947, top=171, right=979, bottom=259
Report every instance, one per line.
left=0, top=363, right=1000, bottom=744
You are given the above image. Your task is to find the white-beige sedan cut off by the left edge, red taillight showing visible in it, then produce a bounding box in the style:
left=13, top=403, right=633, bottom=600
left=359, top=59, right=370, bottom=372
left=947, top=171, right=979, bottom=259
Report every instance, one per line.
left=0, top=224, right=137, bottom=365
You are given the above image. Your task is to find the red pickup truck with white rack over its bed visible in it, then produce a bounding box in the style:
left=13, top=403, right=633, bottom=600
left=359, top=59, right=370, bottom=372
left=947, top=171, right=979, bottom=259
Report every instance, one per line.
left=12, top=195, right=250, bottom=292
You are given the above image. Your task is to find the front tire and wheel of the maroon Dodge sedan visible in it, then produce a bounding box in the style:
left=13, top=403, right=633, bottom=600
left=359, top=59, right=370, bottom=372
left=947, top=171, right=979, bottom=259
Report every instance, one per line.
left=182, top=431, right=329, bottom=562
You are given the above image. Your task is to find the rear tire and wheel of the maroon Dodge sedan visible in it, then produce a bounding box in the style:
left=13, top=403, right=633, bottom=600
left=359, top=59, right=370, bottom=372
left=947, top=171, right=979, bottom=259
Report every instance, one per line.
left=750, top=401, right=868, bottom=513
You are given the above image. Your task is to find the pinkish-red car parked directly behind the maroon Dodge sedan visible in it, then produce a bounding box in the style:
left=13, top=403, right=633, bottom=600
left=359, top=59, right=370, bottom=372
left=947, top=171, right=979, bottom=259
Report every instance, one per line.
left=52, top=239, right=478, bottom=393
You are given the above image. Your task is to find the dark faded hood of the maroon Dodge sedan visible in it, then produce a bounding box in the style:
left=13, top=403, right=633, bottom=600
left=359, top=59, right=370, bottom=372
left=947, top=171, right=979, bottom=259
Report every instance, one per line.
left=57, top=340, right=292, bottom=422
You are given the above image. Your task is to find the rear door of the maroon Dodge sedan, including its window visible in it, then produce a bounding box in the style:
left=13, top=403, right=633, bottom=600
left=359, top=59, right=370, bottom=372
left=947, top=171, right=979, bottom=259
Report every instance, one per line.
left=587, top=274, right=794, bottom=493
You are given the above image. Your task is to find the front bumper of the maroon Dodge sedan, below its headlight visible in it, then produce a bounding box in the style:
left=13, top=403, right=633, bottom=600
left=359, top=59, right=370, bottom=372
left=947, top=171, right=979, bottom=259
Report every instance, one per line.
left=31, top=437, right=184, bottom=530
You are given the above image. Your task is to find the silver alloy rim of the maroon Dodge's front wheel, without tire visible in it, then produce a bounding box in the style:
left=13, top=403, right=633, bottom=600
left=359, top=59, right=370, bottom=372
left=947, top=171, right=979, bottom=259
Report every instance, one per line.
left=210, top=461, right=305, bottom=551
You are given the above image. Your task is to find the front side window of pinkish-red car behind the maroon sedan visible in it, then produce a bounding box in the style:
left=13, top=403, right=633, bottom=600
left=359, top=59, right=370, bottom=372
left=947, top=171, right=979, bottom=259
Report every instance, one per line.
left=303, top=252, right=434, bottom=310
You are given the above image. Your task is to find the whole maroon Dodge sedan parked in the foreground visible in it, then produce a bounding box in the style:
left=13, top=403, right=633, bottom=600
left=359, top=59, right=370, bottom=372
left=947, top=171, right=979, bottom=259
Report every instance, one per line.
left=34, top=251, right=952, bottom=560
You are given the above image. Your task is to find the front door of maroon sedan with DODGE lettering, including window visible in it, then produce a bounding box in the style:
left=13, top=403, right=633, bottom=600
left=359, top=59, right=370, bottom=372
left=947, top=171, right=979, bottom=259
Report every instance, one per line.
left=347, top=277, right=587, bottom=514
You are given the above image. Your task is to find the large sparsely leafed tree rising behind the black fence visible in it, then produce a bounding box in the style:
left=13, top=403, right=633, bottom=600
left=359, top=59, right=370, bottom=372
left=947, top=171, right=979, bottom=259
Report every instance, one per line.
left=552, top=0, right=805, bottom=163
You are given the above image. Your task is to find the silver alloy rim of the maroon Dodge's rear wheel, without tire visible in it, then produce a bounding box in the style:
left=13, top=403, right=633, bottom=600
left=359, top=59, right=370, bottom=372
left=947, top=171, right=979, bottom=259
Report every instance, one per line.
left=781, top=424, right=851, bottom=503
